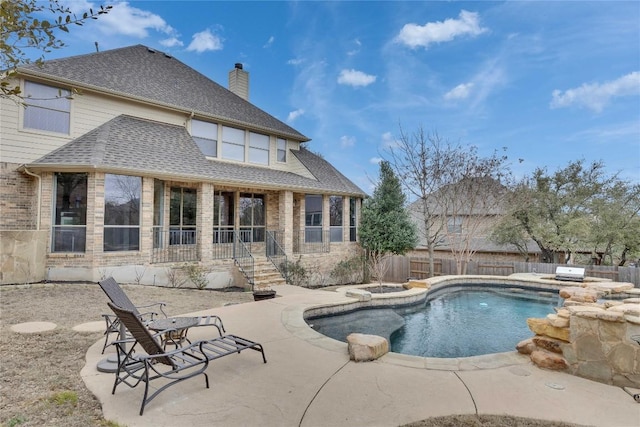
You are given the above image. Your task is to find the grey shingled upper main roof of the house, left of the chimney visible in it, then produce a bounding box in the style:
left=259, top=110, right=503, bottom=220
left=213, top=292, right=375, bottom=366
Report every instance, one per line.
left=18, top=45, right=309, bottom=141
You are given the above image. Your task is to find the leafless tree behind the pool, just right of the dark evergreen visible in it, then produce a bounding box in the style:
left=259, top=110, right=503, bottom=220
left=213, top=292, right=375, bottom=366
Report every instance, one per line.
left=387, top=127, right=511, bottom=276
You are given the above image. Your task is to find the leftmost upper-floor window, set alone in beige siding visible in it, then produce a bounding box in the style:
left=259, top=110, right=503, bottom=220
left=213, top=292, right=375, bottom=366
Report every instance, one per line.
left=22, top=81, right=71, bottom=135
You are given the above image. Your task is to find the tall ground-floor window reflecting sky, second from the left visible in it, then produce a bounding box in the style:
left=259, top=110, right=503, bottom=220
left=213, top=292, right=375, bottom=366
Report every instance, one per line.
left=104, top=174, right=142, bottom=252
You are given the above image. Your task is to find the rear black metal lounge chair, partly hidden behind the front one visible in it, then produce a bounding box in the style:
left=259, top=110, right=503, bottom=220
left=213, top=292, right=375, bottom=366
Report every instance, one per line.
left=98, top=277, right=226, bottom=354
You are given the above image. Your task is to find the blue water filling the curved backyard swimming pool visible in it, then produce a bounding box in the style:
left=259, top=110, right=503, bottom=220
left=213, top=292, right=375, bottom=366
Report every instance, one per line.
left=308, top=290, right=558, bottom=358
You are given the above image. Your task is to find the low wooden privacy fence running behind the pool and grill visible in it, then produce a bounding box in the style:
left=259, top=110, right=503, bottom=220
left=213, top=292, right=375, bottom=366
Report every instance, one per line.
left=384, top=256, right=640, bottom=288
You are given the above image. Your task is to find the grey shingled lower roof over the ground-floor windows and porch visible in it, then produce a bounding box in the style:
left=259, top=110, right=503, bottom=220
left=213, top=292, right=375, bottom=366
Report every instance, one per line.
left=28, top=115, right=365, bottom=197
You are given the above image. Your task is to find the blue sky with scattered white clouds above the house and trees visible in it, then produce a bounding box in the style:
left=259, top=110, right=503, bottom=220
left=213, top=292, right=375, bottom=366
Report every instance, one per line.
left=42, top=0, right=640, bottom=192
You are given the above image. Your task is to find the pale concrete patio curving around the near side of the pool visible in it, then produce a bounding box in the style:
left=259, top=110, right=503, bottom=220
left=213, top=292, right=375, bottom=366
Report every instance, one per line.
left=81, top=285, right=640, bottom=427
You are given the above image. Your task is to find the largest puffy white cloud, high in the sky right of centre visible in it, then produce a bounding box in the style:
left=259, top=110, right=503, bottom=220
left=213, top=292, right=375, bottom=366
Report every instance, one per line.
left=396, top=10, right=487, bottom=49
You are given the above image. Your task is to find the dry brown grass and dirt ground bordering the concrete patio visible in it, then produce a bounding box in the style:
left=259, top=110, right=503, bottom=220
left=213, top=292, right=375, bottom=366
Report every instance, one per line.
left=0, top=284, right=570, bottom=427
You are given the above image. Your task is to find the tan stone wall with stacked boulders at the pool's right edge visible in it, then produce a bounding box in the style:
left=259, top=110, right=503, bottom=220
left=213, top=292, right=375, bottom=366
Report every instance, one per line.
left=517, top=282, right=640, bottom=388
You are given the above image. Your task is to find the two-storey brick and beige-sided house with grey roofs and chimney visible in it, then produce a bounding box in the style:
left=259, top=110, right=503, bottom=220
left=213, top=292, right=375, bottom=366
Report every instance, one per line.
left=0, top=45, right=365, bottom=288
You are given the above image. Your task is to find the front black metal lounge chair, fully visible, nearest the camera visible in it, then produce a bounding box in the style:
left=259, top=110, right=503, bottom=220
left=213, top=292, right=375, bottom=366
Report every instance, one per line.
left=107, top=303, right=267, bottom=415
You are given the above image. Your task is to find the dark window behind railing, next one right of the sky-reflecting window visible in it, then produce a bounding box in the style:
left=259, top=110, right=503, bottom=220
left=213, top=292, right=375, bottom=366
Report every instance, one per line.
left=169, top=187, right=198, bottom=245
